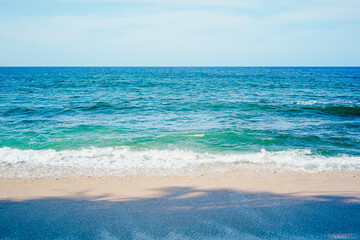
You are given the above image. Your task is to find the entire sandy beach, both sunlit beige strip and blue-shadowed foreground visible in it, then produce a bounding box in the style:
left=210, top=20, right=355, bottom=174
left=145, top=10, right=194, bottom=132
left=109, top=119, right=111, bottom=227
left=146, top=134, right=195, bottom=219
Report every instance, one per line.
left=0, top=170, right=360, bottom=239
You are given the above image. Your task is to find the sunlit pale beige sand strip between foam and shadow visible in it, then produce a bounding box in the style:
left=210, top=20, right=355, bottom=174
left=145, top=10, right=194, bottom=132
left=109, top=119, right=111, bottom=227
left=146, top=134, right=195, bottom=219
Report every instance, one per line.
left=0, top=169, right=360, bottom=201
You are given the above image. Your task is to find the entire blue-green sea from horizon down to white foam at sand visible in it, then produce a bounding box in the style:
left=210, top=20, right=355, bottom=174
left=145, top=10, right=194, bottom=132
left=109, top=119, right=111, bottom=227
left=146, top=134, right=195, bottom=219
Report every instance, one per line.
left=0, top=67, right=360, bottom=176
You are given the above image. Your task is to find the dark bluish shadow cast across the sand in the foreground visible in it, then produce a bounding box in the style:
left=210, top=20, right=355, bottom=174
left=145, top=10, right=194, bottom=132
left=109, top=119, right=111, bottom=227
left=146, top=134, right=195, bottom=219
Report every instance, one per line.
left=0, top=187, right=360, bottom=239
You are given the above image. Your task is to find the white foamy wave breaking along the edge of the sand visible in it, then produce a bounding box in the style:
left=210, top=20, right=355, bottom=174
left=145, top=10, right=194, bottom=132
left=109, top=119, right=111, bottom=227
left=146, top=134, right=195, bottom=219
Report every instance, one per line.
left=0, top=147, right=360, bottom=177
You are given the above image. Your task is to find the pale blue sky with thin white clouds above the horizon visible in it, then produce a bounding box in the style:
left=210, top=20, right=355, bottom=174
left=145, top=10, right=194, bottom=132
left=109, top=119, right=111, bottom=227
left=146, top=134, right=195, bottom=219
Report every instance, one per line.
left=0, top=0, right=360, bottom=66
